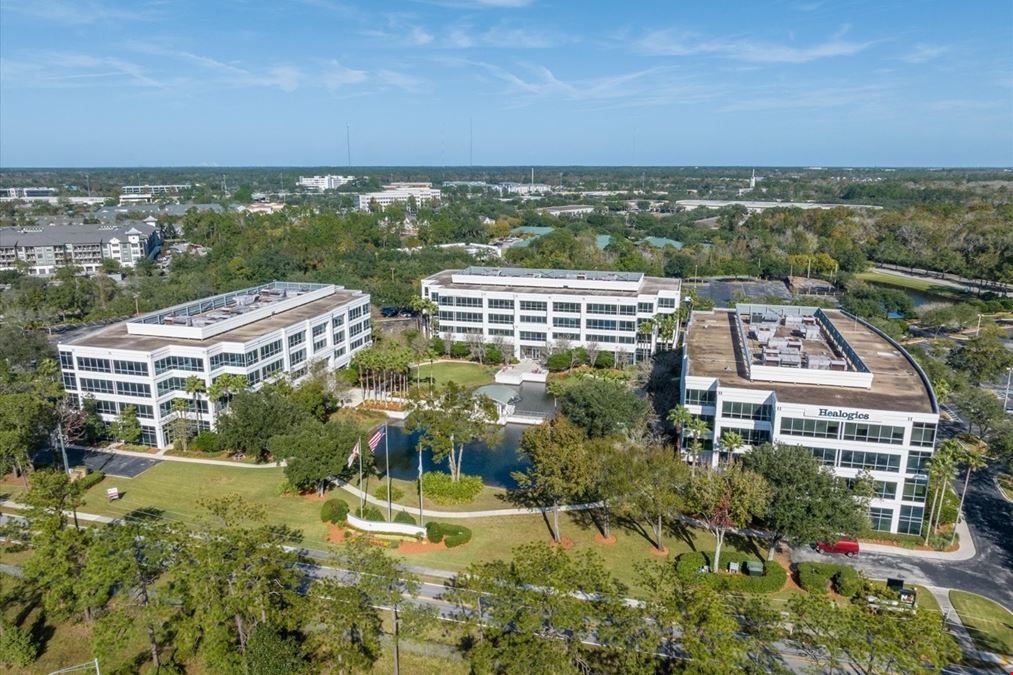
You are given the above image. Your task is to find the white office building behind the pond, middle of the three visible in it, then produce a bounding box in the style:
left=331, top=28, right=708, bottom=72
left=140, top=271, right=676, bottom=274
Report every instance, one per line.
left=422, top=267, right=680, bottom=359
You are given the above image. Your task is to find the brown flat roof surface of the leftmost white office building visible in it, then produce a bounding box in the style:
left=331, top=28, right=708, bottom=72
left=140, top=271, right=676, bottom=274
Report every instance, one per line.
left=60, top=289, right=366, bottom=352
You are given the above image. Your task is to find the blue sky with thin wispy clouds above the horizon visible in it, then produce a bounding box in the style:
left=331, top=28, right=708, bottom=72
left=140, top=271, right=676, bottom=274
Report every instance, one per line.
left=0, top=0, right=1013, bottom=166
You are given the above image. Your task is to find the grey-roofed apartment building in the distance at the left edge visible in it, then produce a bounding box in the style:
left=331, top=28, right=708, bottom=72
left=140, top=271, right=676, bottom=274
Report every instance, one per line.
left=0, top=222, right=160, bottom=277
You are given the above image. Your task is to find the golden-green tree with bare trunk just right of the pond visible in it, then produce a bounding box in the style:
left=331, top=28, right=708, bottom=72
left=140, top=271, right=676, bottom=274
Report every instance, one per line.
left=513, top=416, right=595, bottom=543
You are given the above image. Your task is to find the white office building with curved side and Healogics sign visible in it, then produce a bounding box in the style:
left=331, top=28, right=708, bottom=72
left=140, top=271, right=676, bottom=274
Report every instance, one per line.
left=681, top=304, right=939, bottom=534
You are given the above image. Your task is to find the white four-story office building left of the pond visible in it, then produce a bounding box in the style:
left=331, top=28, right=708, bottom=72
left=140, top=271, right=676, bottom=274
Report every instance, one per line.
left=59, top=282, right=372, bottom=448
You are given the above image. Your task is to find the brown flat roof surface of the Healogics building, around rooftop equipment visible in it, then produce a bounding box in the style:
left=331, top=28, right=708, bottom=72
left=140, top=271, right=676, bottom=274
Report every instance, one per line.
left=686, top=309, right=934, bottom=413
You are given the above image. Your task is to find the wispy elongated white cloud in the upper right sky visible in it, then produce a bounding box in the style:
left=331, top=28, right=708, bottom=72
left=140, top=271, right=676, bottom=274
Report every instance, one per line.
left=636, top=27, right=872, bottom=64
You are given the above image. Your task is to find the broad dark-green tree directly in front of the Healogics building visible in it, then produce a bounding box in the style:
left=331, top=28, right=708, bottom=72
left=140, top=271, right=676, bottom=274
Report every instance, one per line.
left=742, top=443, right=868, bottom=560
